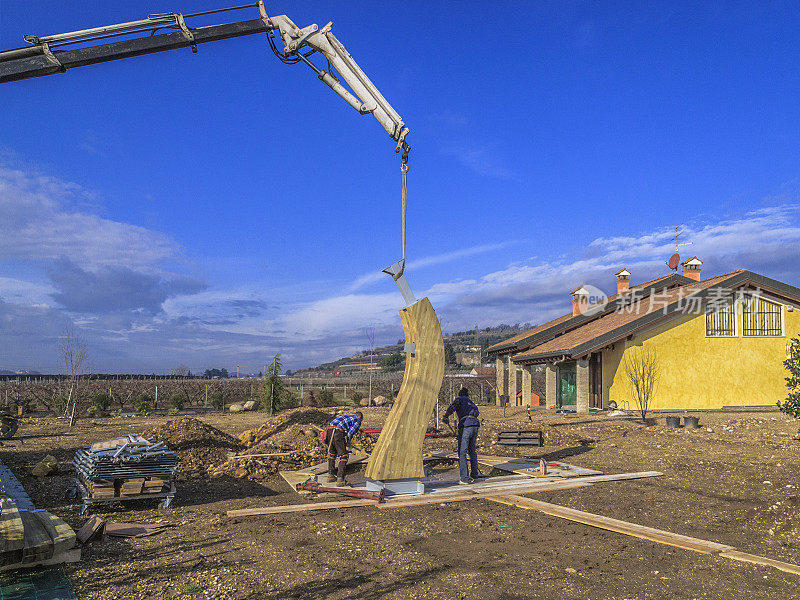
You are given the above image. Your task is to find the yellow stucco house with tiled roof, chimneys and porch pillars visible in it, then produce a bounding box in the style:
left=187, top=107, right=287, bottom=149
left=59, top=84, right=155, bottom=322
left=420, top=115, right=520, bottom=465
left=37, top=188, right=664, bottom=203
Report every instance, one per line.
left=488, top=257, right=800, bottom=412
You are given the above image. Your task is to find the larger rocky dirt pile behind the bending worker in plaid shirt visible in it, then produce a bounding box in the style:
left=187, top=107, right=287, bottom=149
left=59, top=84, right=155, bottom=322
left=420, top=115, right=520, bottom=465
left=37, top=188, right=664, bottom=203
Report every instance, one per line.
left=210, top=408, right=374, bottom=480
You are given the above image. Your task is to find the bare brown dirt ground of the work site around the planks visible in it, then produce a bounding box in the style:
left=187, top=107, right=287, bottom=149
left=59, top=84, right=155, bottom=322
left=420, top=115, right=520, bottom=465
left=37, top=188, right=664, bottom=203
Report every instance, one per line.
left=0, top=407, right=800, bottom=600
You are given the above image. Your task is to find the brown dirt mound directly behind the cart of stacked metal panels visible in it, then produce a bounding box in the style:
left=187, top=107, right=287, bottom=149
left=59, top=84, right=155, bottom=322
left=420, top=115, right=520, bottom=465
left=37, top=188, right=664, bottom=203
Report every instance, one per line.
left=142, top=417, right=241, bottom=472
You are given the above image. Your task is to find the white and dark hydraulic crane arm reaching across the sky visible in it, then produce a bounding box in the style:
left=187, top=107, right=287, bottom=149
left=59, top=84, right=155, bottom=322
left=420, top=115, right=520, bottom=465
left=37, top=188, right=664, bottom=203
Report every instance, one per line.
left=0, top=0, right=410, bottom=158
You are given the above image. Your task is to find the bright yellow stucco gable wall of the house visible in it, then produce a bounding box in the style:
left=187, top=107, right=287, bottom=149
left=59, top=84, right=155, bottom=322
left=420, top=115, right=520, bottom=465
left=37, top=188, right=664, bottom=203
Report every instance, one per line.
left=603, top=305, right=800, bottom=409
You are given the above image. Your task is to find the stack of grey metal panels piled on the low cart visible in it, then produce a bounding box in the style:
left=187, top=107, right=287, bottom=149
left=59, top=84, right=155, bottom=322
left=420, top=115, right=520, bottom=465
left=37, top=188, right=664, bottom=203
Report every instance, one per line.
left=72, top=435, right=178, bottom=482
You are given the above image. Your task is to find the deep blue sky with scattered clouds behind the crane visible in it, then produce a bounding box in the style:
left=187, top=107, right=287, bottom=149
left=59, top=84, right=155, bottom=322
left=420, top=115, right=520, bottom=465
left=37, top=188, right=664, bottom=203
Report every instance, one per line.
left=0, top=0, right=800, bottom=372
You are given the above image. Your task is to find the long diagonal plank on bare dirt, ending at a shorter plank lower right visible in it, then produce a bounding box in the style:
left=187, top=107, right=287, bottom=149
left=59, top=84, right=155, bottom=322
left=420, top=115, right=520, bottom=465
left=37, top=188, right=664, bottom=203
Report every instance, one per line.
left=496, top=496, right=734, bottom=554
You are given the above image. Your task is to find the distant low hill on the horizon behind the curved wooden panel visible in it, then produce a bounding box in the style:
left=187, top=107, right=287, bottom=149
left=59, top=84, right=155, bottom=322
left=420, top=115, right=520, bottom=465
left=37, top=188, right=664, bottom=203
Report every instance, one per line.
left=295, top=323, right=532, bottom=374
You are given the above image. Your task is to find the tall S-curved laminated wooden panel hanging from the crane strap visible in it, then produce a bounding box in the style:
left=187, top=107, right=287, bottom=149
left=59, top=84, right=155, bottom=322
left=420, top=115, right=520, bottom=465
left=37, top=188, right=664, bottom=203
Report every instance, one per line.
left=366, top=298, right=444, bottom=481
